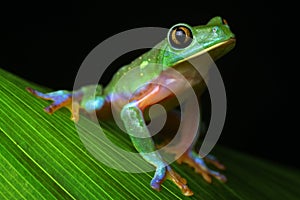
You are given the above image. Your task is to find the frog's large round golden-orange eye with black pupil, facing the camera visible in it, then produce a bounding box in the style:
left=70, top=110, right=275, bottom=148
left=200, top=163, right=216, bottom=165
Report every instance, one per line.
left=168, top=25, right=193, bottom=49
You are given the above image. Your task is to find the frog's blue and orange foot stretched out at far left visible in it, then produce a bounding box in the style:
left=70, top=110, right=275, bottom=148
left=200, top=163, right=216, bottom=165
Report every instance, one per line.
left=26, top=88, right=79, bottom=121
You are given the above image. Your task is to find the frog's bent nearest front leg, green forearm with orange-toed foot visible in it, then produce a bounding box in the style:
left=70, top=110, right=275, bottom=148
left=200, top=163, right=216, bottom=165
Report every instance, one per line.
left=121, top=83, right=193, bottom=196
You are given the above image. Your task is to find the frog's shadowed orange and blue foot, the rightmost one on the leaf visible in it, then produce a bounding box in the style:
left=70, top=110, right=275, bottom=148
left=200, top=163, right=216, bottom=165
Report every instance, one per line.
left=177, top=150, right=227, bottom=183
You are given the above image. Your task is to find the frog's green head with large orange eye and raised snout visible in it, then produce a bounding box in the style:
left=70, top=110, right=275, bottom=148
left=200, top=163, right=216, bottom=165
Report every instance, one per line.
left=163, top=16, right=235, bottom=66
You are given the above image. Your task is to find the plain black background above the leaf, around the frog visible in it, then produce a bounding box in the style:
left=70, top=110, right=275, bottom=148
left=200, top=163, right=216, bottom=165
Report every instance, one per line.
left=0, top=0, right=299, bottom=167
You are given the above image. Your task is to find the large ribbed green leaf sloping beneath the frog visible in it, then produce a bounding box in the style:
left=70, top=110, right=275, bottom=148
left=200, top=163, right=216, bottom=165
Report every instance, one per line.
left=0, top=69, right=300, bottom=200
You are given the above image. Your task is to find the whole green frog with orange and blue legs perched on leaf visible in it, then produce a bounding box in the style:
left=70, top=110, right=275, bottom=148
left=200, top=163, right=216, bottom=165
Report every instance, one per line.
left=27, top=16, right=235, bottom=196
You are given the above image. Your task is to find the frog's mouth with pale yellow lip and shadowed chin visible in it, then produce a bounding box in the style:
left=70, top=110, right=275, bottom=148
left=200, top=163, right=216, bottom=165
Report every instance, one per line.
left=177, top=38, right=236, bottom=64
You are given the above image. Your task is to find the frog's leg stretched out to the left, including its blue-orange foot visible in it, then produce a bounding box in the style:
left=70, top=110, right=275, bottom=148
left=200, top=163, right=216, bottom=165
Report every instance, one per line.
left=26, top=85, right=105, bottom=122
